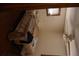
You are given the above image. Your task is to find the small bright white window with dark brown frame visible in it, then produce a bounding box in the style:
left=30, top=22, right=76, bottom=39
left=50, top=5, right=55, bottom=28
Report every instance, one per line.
left=47, top=8, right=60, bottom=16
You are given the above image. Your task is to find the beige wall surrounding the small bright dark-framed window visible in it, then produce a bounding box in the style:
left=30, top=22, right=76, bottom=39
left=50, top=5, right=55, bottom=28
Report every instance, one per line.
left=38, top=8, right=65, bottom=32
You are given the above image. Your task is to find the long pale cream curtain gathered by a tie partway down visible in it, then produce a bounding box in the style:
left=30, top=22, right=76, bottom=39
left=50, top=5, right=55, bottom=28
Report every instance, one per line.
left=64, top=8, right=77, bottom=55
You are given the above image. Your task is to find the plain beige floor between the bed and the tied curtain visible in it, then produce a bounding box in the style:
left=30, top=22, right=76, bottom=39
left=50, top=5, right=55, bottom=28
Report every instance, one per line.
left=36, top=32, right=66, bottom=55
